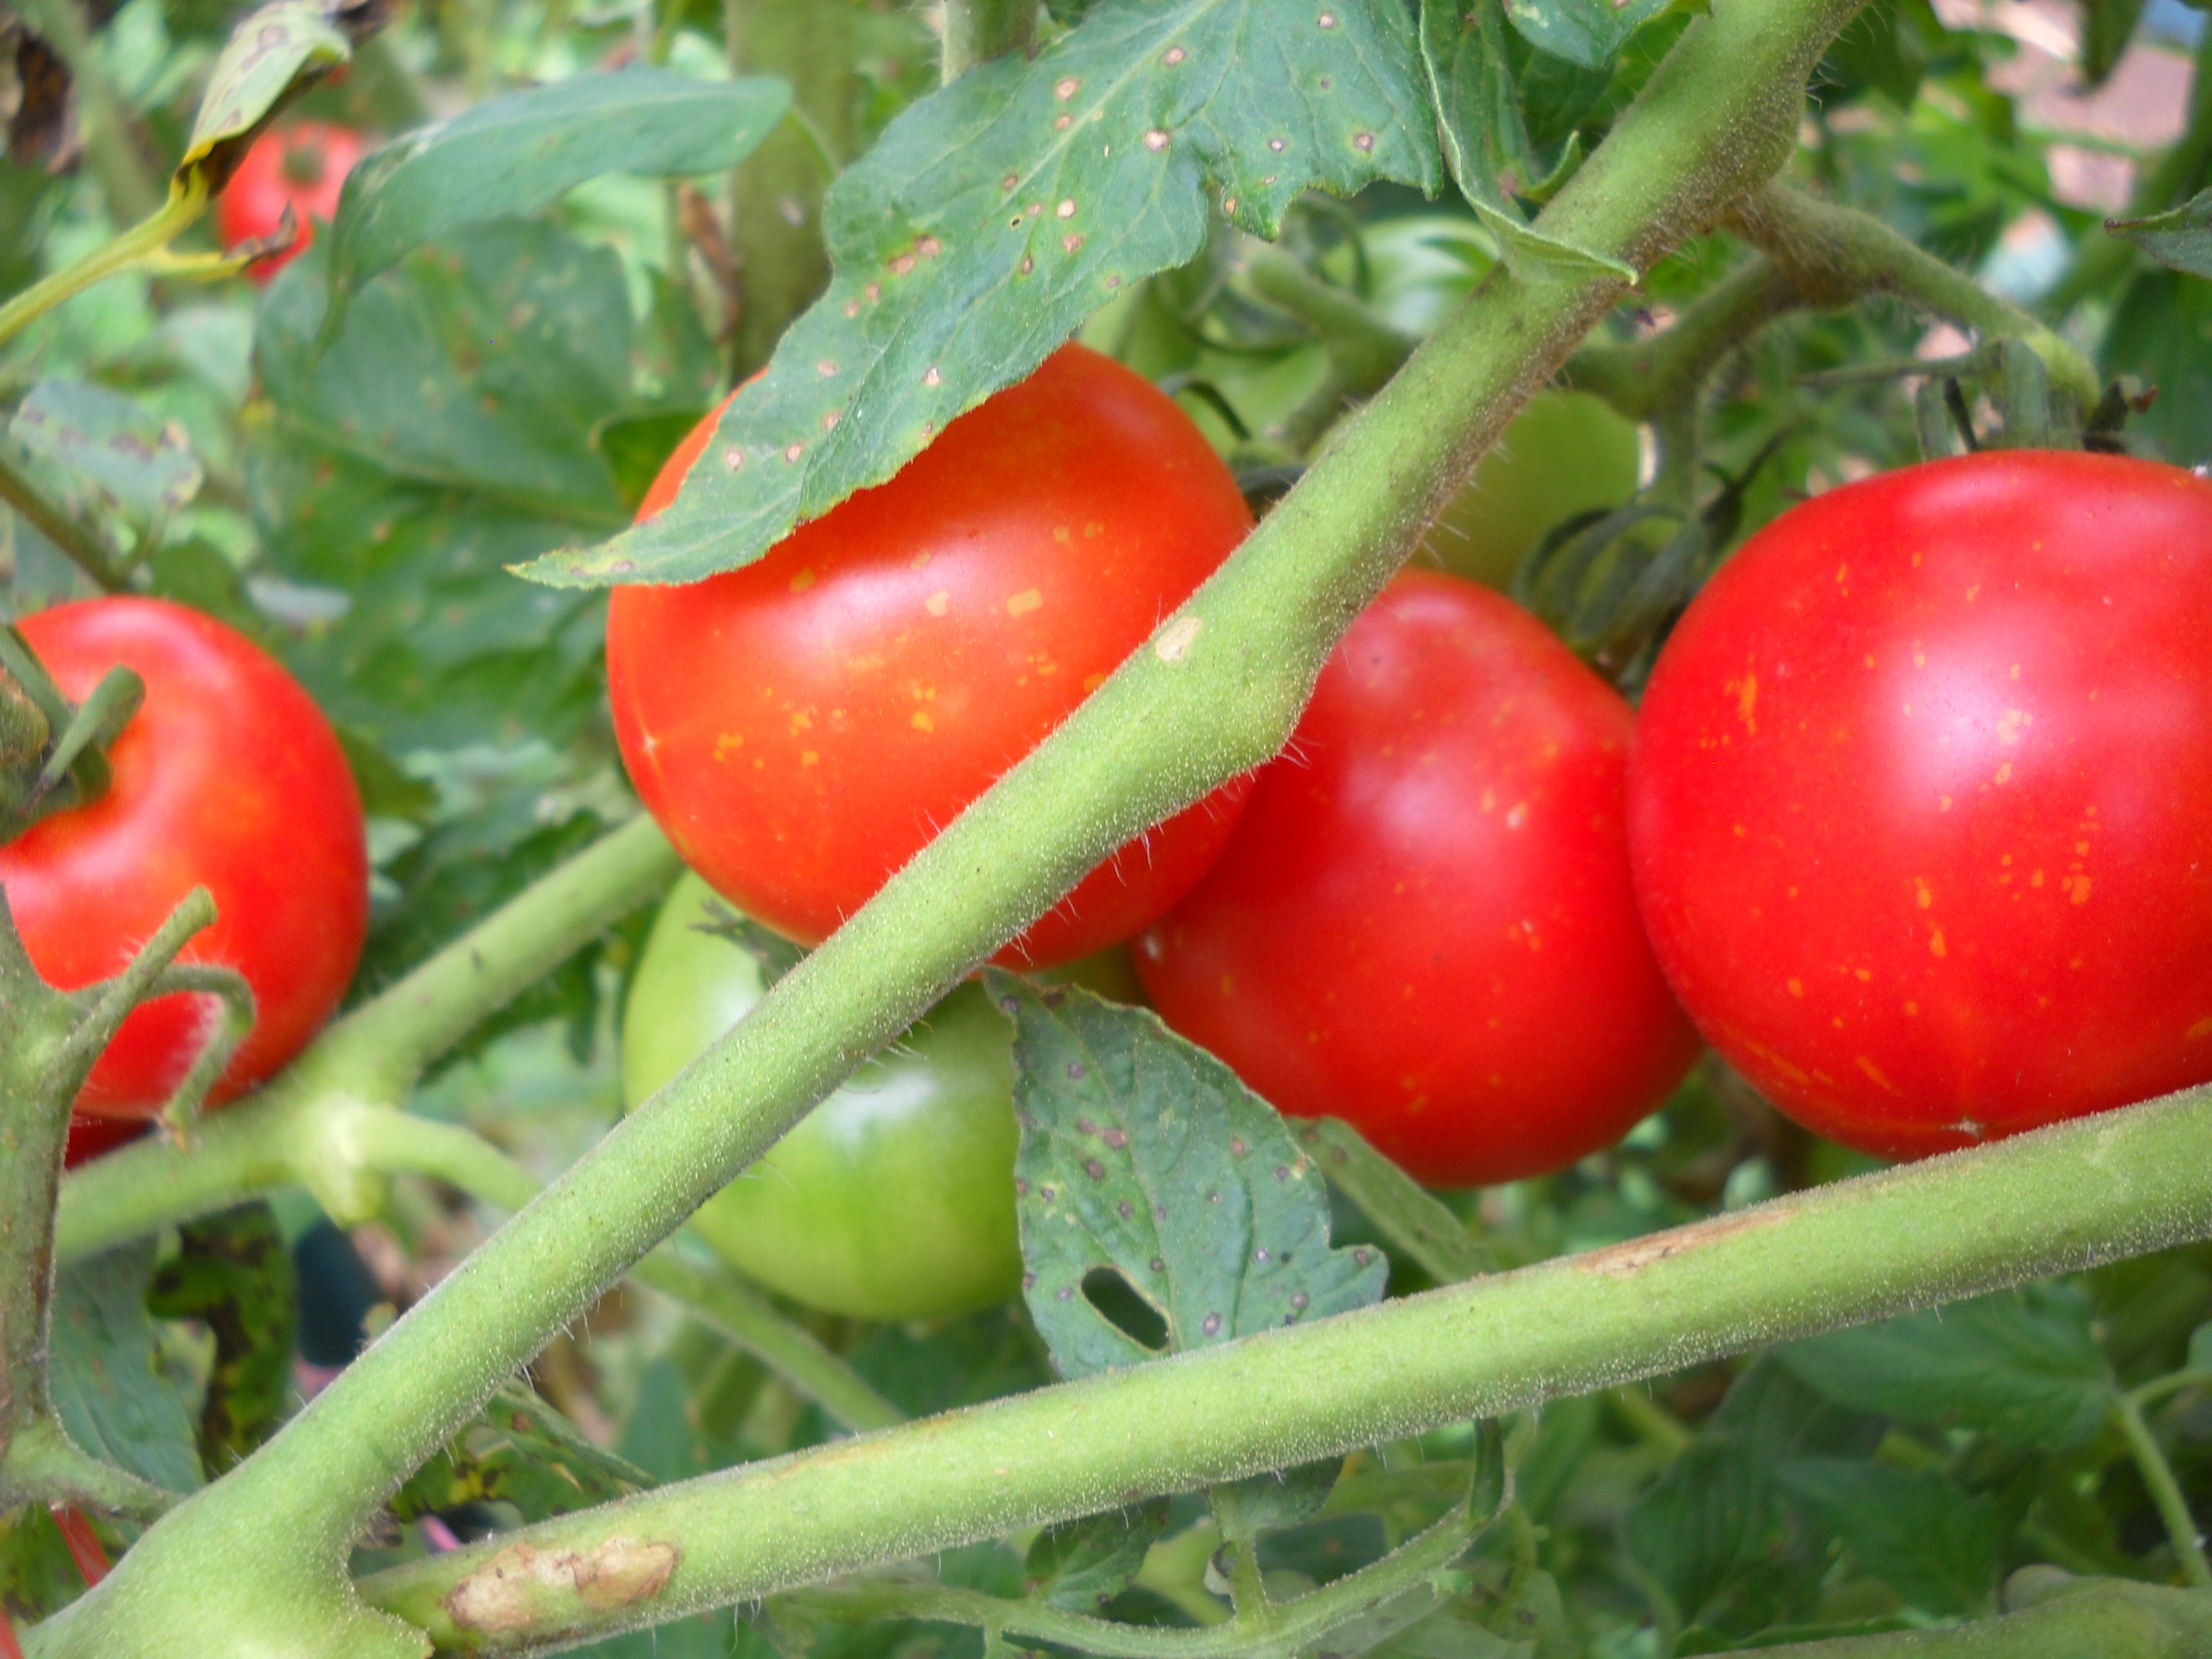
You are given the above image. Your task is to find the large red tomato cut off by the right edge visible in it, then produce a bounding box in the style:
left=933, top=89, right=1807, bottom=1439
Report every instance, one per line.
left=1631, top=451, right=2212, bottom=1157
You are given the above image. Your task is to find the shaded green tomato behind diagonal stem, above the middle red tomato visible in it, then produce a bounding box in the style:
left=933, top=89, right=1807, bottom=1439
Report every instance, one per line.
left=1422, top=392, right=1641, bottom=588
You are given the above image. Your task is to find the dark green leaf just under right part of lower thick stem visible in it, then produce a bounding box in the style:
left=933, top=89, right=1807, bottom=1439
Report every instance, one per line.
left=1778, top=1285, right=2112, bottom=1451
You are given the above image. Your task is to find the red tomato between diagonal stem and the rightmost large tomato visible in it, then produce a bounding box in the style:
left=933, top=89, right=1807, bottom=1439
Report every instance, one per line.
left=1137, top=573, right=1696, bottom=1186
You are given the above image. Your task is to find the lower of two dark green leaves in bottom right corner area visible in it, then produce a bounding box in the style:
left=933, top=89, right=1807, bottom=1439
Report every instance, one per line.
left=1776, top=1458, right=2000, bottom=1615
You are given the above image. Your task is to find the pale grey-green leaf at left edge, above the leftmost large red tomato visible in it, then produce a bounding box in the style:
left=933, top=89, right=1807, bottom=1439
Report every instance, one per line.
left=9, top=380, right=206, bottom=531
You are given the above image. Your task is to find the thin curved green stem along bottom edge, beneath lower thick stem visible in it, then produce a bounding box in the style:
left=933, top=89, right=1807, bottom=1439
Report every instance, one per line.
left=774, top=1500, right=1486, bottom=1659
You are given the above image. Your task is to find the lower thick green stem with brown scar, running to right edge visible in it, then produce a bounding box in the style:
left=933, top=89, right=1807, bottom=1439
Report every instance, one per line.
left=361, top=1090, right=2212, bottom=1652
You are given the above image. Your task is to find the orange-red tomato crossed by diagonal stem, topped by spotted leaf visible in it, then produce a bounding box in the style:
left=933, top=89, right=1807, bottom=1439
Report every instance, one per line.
left=606, top=345, right=1252, bottom=966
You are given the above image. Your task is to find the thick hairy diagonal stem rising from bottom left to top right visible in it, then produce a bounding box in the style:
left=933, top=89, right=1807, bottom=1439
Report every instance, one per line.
left=21, top=0, right=1880, bottom=1659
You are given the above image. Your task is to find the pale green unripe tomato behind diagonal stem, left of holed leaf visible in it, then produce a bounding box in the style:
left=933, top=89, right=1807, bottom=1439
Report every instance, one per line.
left=621, top=874, right=1022, bottom=1318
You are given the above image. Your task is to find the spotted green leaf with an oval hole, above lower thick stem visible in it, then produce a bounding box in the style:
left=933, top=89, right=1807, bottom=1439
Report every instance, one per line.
left=984, top=969, right=1389, bottom=1378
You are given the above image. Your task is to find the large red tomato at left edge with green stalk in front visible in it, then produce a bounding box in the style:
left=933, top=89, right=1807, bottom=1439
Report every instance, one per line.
left=0, top=600, right=369, bottom=1117
